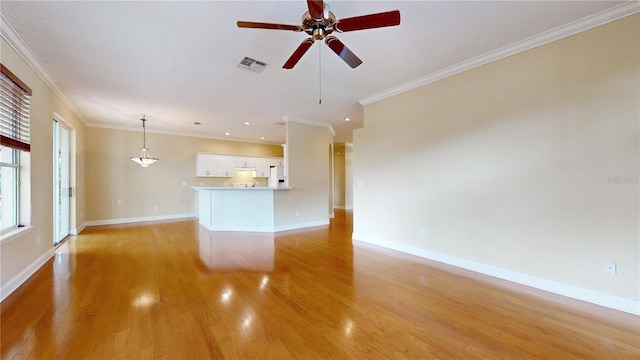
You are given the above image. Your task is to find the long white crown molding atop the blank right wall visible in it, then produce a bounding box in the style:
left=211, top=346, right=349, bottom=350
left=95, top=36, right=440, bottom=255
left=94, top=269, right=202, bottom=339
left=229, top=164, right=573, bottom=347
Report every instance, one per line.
left=358, top=0, right=640, bottom=106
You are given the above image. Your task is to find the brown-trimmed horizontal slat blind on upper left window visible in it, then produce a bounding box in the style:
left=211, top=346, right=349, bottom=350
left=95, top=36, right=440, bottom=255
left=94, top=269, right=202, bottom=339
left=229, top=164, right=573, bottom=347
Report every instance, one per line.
left=0, top=64, right=31, bottom=151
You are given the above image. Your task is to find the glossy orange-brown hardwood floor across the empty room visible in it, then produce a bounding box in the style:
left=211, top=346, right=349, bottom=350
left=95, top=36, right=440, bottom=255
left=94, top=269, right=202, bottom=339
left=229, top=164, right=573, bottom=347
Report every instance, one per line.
left=1, top=211, right=640, bottom=360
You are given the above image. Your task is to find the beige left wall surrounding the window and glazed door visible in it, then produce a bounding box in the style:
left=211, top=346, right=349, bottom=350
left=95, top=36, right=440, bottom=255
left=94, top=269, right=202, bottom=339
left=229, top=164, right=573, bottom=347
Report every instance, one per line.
left=0, top=38, right=86, bottom=290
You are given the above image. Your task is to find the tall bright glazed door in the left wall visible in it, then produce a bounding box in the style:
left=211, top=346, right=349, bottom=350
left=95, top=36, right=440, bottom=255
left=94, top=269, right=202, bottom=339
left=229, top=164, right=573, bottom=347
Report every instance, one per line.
left=53, top=120, right=71, bottom=245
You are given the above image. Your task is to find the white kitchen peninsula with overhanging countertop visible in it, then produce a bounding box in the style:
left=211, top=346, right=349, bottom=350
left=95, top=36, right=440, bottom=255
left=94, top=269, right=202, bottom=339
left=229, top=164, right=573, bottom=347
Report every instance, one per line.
left=193, top=187, right=291, bottom=232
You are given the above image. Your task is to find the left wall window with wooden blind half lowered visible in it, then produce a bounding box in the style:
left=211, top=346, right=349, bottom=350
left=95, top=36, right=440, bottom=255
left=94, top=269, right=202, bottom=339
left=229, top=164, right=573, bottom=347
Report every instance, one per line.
left=0, top=64, right=31, bottom=233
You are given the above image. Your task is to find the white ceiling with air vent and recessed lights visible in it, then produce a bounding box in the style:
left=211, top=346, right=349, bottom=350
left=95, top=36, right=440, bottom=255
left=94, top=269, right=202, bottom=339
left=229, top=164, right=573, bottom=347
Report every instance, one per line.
left=1, top=0, right=632, bottom=144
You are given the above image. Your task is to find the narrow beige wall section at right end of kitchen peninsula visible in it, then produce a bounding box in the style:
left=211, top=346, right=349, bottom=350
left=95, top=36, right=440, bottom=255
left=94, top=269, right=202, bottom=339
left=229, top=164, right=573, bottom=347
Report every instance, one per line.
left=275, top=121, right=333, bottom=228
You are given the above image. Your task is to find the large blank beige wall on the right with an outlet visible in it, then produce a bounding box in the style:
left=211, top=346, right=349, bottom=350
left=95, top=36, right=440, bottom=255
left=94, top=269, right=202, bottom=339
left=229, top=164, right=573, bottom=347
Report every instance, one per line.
left=354, top=15, right=640, bottom=304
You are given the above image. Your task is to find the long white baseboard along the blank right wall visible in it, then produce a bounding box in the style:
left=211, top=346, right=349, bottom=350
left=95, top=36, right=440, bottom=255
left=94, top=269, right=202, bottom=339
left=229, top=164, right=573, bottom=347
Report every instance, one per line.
left=352, top=233, right=640, bottom=315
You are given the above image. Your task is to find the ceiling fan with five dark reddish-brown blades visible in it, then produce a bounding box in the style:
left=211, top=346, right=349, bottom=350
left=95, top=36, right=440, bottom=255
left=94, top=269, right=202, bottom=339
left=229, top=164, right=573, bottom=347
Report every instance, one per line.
left=238, top=0, right=400, bottom=69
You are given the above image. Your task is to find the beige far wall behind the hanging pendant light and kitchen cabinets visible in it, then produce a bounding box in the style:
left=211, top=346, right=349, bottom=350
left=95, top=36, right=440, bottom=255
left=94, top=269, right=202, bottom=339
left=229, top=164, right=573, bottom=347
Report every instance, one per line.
left=86, top=126, right=283, bottom=224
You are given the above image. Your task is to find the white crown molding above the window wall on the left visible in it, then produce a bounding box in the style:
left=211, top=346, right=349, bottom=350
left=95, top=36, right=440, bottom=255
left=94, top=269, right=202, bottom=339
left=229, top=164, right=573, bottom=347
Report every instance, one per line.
left=0, top=14, right=87, bottom=125
